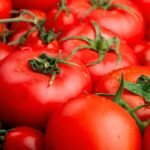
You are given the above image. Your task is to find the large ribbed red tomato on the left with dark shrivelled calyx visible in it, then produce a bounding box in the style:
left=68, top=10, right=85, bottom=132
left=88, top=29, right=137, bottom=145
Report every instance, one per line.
left=0, top=47, right=91, bottom=129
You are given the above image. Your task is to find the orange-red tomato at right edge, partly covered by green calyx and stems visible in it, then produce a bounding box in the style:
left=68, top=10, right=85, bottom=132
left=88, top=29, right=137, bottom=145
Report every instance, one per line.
left=94, top=66, right=150, bottom=120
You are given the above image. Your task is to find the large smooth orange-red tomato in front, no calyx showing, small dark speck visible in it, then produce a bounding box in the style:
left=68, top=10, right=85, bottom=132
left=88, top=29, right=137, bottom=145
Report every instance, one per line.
left=46, top=95, right=141, bottom=150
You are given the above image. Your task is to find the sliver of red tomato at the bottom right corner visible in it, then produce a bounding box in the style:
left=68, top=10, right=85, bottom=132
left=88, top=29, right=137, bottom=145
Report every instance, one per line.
left=142, top=125, right=150, bottom=150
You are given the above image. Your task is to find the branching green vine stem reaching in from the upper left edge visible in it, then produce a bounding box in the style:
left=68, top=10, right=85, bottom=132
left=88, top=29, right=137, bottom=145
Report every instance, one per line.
left=0, top=9, right=60, bottom=45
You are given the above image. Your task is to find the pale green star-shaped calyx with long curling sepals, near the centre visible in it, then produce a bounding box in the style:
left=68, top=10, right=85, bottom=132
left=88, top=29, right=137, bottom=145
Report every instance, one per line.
left=61, top=21, right=121, bottom=66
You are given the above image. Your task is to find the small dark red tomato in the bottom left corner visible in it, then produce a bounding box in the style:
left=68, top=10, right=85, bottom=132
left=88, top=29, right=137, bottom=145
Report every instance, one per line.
left=3, top=127, right=44, bottom=150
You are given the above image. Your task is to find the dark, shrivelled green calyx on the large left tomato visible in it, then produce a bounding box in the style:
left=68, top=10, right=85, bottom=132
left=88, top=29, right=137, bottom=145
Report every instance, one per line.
left=28, top=53, right=77, bottom=86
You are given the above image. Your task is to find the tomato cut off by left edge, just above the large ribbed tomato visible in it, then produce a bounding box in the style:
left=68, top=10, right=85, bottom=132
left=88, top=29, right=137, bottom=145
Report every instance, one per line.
left=0, top=42, right=14, bottom=61
